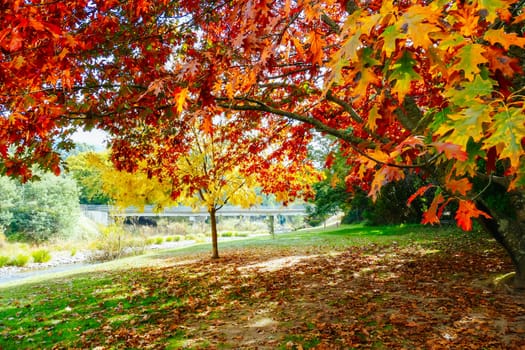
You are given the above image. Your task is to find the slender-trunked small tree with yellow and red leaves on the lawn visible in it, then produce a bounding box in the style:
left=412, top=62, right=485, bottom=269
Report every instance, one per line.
left=91, top=115, right=321, bottom=258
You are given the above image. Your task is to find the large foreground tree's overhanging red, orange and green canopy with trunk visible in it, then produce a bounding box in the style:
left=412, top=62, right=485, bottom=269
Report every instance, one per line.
left=0, top=0, right=525, bottom=287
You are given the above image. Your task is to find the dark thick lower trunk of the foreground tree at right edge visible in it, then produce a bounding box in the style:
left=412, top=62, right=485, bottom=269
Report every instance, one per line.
left=477, top=191, right=525, bottom=290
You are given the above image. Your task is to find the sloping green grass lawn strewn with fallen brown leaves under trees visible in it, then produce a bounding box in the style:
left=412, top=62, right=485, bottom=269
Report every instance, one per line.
left=0, top=225, right=525, bottom=349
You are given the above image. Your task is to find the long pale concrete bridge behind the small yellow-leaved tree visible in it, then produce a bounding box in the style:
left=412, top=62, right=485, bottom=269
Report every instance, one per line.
left=80, top=205, right=306, bottom=225
